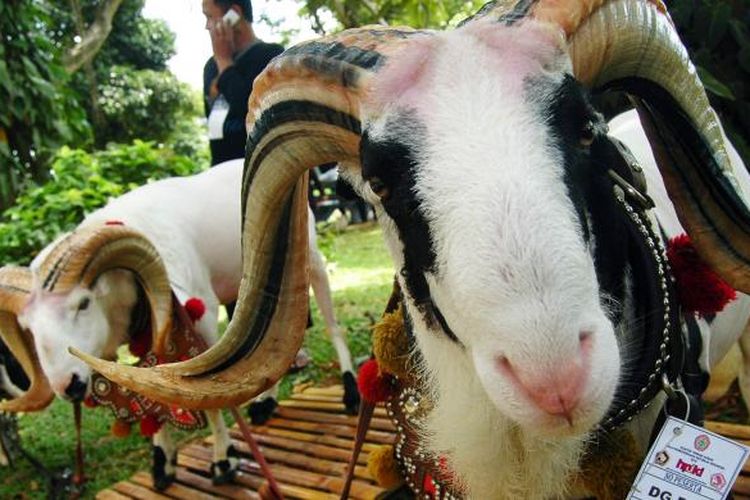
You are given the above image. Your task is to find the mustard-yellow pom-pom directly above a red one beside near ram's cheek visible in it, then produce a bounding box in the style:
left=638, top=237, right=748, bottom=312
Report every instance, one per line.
left=372, top=307, right=409, bottom=379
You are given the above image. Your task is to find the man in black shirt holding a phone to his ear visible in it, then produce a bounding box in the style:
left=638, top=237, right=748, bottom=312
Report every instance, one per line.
left=203, top=0, right=284, bottom=166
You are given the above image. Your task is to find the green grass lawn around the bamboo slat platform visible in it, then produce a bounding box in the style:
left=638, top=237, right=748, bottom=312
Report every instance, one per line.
left=0, top=224, right=393, bottom=499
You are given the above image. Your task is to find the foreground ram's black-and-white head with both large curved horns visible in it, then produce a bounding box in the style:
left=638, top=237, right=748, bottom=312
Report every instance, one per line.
left=76, top=0, right=750, bottom=498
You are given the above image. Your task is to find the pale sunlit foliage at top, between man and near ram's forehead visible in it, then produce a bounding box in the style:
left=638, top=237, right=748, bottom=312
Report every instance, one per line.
left=303, top=0, right=485, bottom=33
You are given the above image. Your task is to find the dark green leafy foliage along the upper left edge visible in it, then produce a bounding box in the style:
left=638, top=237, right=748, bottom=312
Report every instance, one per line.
left=0, top=2, right=88, bottom=209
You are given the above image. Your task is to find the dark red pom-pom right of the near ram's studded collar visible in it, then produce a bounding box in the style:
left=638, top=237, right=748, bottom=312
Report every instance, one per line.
left=667, top=234, right=737, bottom=316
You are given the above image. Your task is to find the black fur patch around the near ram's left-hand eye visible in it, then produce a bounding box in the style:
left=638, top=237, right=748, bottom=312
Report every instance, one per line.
left=360, top=123, right=458, bottom=341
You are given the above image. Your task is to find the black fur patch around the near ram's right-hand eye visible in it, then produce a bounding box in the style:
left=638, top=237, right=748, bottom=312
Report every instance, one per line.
left=527, top=75, right=629, bottom=322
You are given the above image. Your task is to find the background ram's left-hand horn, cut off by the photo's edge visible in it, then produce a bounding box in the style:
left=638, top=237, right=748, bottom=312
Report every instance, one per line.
left=0, top=266, right=55, bottom=412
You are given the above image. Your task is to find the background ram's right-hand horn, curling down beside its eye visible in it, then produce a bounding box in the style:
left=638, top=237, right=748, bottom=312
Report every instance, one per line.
left=36, top=224, right=172, bottom=353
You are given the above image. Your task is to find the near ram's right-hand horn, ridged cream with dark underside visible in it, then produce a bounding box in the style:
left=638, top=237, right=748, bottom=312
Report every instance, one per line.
left=529, top=0, right=750, bottom=292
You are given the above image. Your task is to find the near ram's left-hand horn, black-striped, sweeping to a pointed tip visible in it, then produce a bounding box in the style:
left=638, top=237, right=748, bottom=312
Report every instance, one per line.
left=76, top=27, right=432, bottom=408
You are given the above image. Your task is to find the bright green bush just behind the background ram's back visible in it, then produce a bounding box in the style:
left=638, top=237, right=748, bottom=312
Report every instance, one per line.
left=0, top=141, right=205, bottom=264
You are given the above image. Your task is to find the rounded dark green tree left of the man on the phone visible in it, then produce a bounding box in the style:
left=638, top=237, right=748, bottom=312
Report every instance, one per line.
left=47, top=0, right=194, bottom=147
